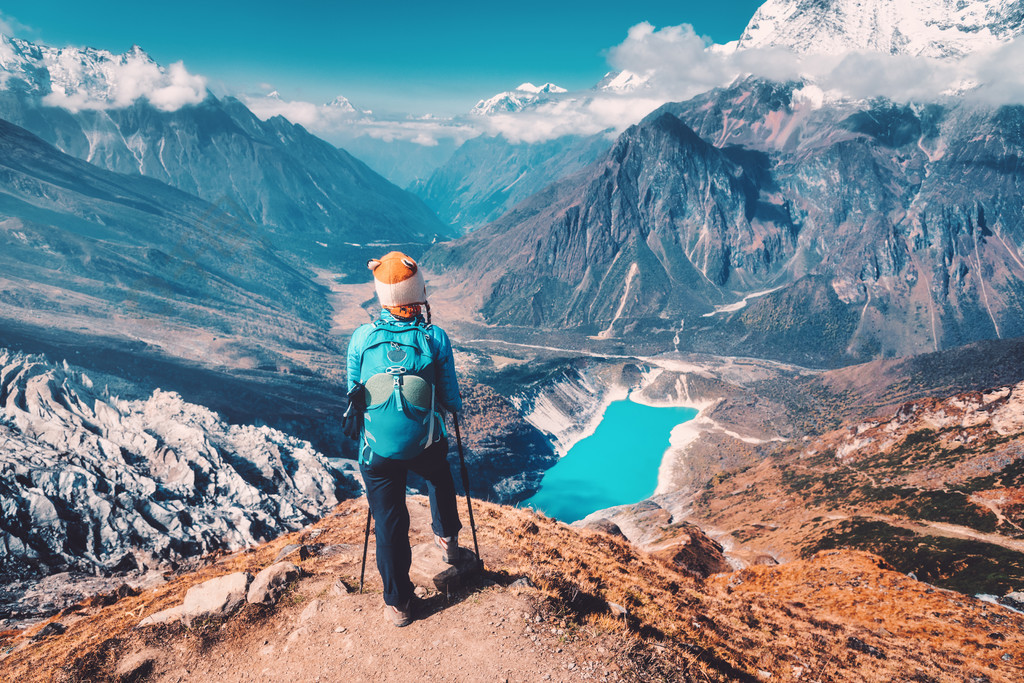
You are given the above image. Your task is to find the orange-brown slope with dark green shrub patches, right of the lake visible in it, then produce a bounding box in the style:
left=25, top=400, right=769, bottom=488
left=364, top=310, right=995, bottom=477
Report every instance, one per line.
left=667, top=374, right=1024, bottom=595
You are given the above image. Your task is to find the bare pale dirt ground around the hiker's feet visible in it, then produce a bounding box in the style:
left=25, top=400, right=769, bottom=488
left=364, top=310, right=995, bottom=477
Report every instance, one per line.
left=144, top=499, right=621, bottom=683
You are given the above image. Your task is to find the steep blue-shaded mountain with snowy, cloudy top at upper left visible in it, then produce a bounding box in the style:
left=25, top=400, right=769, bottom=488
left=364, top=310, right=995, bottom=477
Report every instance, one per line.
left=0, top=38, right=451, bottom=267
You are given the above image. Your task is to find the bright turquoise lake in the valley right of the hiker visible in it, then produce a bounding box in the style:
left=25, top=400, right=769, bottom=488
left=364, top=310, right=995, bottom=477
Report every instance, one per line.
left=521, top=400, right=697, bottom=522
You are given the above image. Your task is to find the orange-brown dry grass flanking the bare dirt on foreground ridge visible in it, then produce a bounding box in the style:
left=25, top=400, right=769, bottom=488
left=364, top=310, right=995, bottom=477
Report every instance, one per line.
left=0, top=501, right=1024, bottom=683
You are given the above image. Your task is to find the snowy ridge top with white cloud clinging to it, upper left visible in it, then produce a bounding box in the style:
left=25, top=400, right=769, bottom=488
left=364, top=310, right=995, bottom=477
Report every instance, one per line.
left=0, top=35, right=206, bottom=112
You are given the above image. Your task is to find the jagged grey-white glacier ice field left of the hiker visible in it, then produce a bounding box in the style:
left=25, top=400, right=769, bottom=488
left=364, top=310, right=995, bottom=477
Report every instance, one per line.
left=0, top=349, right=358, bottom=617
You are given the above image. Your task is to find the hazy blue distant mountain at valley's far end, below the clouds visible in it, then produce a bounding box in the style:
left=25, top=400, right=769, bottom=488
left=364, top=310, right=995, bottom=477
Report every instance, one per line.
left=410, top=135, right=611, bottom=230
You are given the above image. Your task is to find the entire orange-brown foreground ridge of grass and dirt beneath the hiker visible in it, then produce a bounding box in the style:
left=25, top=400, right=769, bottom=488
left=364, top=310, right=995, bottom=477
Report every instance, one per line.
left=0, top=499, right=1024, bottom=683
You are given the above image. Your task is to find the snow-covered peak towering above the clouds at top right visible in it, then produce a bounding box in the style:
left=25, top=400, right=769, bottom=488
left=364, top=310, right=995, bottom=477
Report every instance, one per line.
left=738, top=0, right=1024, bottom=57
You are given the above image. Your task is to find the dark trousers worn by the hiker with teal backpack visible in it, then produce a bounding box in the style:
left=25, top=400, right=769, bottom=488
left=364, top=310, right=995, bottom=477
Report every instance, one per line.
left=359, top=436, right=462, bottom=606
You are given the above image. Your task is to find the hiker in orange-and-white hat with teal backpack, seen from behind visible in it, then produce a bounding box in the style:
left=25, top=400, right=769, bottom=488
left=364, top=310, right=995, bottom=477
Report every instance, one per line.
left=346, top=252, right=462, bottom=627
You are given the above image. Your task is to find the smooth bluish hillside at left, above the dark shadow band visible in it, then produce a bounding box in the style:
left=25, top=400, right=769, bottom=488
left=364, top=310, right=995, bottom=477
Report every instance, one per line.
left=0, top=116, right=328, bottom=355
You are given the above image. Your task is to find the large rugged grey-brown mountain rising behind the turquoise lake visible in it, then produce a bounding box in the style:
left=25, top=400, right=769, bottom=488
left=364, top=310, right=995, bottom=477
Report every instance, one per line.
left=428, top=80, right=1024, bottom=365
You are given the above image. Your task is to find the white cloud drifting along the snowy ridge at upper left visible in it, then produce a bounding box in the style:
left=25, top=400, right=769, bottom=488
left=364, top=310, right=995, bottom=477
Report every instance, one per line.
left=43, top=48, right=206, bottom=112
